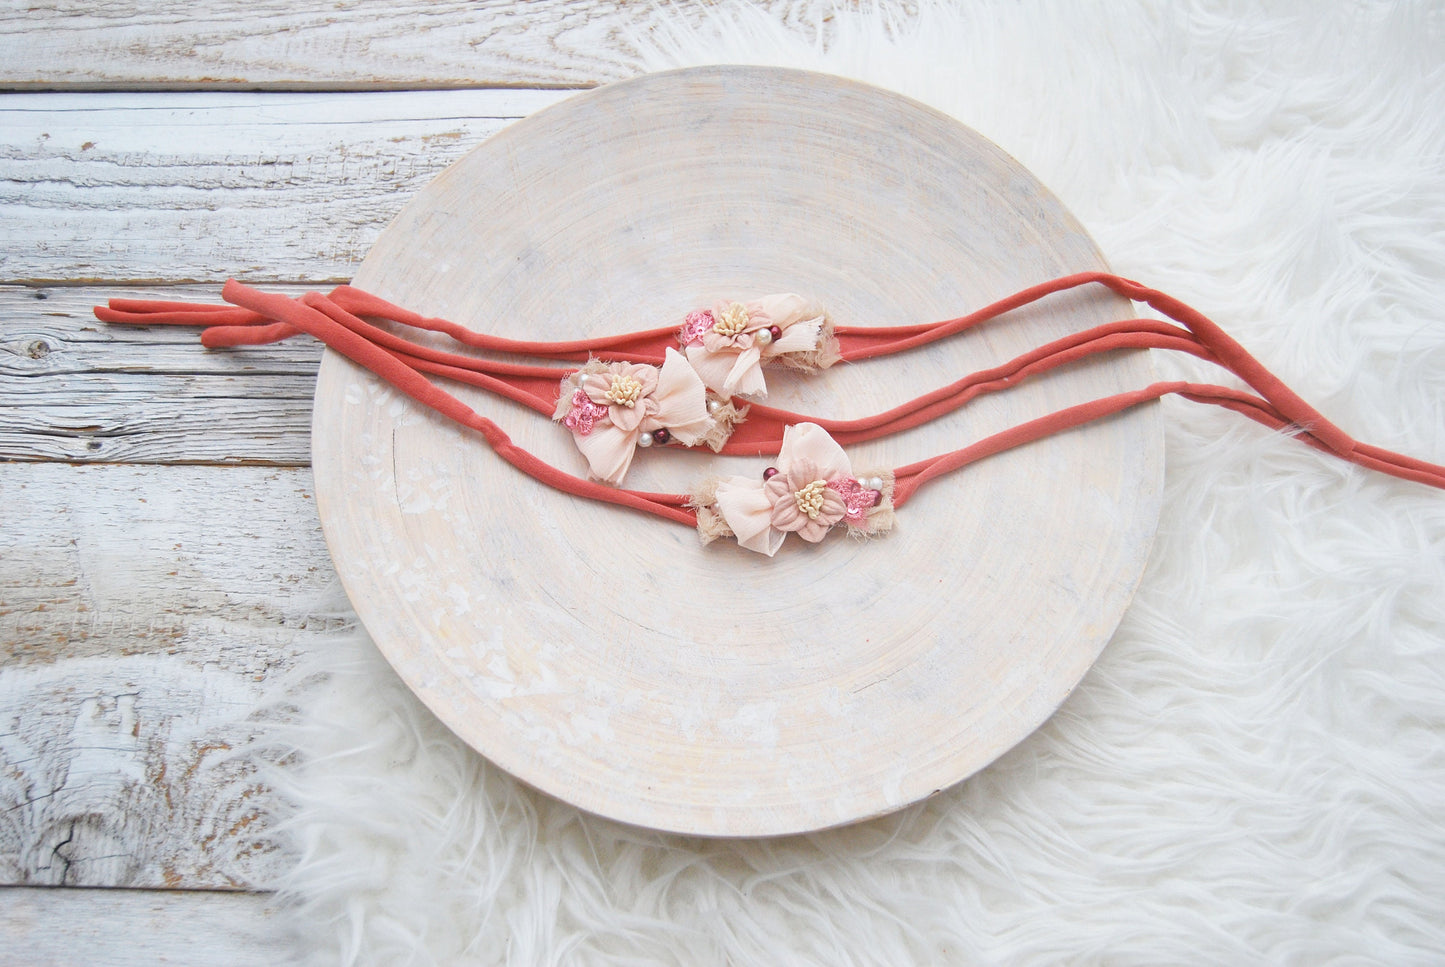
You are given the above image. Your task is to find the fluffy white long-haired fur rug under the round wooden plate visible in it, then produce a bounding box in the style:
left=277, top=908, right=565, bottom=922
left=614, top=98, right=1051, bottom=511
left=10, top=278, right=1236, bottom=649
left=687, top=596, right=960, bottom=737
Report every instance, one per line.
left=265, top=0, right=1445, bottom=966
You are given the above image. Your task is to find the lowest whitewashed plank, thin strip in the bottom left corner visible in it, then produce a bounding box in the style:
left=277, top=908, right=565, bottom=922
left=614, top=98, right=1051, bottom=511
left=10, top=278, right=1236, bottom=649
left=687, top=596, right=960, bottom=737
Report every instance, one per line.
left=0, top=886, right=305, bottom=967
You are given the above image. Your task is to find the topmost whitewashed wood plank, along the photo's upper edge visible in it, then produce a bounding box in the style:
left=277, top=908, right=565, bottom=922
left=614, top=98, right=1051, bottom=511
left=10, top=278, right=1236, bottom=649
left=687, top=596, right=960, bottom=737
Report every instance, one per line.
left=0, top=0, right=832, bottom=90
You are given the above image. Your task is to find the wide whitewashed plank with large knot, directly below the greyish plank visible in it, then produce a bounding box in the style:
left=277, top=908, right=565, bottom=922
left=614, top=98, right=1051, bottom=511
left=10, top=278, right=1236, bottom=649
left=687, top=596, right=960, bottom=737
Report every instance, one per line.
left=0, top=464, right=335, bottom=889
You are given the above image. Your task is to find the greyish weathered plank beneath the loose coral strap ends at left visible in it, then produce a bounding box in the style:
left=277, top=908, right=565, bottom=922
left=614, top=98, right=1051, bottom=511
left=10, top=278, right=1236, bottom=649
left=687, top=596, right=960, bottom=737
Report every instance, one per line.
left=0, top=285, right=321, bottom=467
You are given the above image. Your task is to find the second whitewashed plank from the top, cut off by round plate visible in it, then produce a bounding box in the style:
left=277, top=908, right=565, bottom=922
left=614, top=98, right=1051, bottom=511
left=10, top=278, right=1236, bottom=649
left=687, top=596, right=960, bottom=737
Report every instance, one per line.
left=0, top=91, right=566, bottom=285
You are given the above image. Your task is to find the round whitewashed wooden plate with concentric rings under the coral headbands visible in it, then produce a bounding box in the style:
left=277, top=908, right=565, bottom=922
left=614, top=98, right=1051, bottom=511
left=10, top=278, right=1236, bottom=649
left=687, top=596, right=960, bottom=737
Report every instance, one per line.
left=314, top=66, right=1163, bottom=835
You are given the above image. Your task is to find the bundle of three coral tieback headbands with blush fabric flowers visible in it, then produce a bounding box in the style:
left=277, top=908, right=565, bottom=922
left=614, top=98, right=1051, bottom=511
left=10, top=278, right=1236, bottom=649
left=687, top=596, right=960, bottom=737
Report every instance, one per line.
left=95, top=272, right=1445, bottom=555
